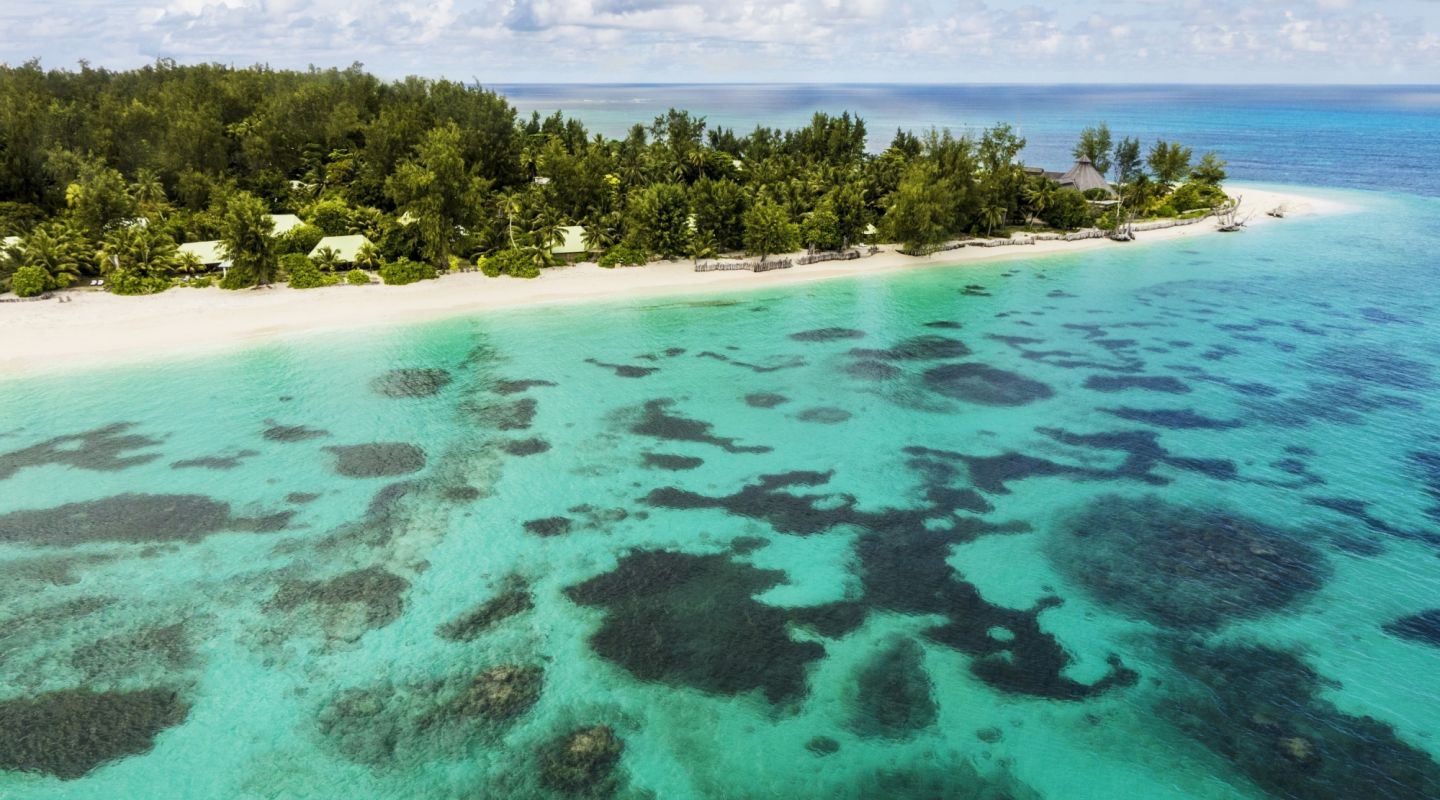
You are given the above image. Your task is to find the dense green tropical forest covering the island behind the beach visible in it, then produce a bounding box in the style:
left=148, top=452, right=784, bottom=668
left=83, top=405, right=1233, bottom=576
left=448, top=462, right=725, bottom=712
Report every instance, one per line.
left=0, top=60, right=1225, bottom=296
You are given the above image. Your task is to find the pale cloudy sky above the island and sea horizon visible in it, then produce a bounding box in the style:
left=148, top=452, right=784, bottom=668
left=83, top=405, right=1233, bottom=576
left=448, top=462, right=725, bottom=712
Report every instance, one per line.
left=0, top=0, right=1440, bottom=83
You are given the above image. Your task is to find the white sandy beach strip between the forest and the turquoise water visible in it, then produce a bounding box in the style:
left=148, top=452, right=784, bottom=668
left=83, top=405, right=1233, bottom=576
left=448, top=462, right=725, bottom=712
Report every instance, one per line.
left=0, top=184, right=1348, bottom=378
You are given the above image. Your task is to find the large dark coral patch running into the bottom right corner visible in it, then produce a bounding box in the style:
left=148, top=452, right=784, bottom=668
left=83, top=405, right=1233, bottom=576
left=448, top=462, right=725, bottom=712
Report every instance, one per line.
left=1161, top=645, right=1440, bottom=800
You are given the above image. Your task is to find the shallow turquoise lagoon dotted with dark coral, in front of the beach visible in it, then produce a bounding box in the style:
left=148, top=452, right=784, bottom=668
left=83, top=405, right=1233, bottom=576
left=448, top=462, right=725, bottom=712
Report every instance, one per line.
left=0, top=184, right=1440, bottom=799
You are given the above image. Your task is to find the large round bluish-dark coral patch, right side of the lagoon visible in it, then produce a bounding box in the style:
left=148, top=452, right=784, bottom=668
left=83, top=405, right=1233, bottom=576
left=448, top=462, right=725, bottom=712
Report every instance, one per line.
left=1050, top=495, right=1329, bottom=629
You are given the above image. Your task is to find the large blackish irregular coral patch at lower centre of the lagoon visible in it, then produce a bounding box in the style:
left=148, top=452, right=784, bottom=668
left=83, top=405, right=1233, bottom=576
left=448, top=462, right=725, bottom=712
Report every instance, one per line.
left=566, top=551, right=825, bottom=702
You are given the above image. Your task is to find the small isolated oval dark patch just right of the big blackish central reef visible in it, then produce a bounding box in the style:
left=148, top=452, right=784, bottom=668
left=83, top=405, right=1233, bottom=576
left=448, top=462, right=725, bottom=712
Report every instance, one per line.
left=850, top=639, right=939, bottom=738
